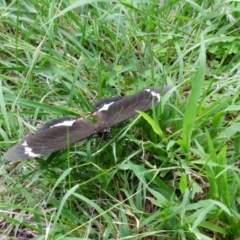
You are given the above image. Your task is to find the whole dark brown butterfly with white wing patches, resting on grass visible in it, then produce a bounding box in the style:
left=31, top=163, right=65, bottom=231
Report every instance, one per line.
left=3, top=86, right=170, bottom=161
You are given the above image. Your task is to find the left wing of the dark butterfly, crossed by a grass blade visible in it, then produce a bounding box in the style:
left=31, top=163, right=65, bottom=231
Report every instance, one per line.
left=4, top=117, right=96, bottom=161
